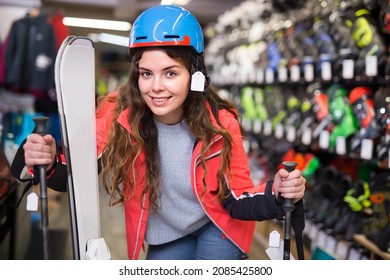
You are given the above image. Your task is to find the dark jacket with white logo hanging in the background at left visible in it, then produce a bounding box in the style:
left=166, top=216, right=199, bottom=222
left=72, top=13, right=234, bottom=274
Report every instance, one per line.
left=5, top=12, right=56, bottom=92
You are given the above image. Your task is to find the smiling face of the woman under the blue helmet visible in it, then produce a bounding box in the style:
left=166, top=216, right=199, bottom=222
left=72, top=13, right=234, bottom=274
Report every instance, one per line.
left=138, top=49, right=190, bottom=124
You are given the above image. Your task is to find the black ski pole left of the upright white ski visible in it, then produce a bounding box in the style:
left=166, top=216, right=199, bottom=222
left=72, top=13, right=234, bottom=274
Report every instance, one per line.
left=33, top=117, right=49, bottom=260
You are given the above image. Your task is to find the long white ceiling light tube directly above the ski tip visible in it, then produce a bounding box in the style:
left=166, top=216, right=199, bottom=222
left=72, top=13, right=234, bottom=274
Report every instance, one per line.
left=62, top=17, right=131, bottom=31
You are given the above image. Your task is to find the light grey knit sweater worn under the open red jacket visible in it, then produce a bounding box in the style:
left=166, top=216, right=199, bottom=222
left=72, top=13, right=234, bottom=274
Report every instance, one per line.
left=146, top=121, right=209, bottom=245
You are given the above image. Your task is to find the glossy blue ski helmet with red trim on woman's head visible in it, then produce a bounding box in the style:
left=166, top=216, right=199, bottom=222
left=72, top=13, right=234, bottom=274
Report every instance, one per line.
left=129, top=5, right=204, bottom=54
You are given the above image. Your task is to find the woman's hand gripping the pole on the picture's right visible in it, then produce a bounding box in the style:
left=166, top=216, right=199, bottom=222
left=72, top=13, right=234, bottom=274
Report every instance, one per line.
left=272, top=169, right=306, bottom=202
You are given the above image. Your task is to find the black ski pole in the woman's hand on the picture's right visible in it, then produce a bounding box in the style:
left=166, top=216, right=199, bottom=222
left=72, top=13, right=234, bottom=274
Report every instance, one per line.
left=282, top=161, right=298, bottom=260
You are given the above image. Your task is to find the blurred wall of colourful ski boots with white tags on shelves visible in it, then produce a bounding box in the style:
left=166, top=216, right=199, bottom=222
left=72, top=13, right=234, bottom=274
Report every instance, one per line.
left=205, top=0, right=390, bottom=259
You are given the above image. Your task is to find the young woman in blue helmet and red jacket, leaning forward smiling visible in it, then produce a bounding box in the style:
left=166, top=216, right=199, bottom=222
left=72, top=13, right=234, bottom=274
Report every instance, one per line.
left=10, top=5, right=306, bottom=259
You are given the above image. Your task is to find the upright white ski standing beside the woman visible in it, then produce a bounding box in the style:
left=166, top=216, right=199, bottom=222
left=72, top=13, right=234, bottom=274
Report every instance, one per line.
left=55, top=36, right=110, bottom=260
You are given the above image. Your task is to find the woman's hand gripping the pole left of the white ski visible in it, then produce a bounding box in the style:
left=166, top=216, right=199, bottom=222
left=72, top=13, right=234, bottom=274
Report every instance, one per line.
left=23, top=133, right=56, bottom=170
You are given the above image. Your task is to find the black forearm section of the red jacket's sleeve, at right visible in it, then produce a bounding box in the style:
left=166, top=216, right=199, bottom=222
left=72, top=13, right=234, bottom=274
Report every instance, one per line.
left=222, top=181, right=280, bottom=221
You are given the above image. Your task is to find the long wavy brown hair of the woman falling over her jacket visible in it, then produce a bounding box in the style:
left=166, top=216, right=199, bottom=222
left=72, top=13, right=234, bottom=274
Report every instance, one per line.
left=101, top=47, right=243, bottom=209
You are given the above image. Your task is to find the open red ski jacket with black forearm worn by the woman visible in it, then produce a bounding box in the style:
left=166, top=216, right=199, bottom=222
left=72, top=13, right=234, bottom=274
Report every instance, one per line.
left=96, top=93, right=278, bottom=259
